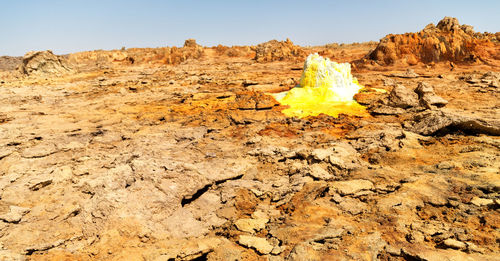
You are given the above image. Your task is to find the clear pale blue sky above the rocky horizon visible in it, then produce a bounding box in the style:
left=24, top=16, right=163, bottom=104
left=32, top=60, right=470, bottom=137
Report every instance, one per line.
left=0, top=0, right=500, bottom=56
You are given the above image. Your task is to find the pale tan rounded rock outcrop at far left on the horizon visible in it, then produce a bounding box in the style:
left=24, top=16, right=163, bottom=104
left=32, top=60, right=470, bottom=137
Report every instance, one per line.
left=19, top=50, right=71, bottom=75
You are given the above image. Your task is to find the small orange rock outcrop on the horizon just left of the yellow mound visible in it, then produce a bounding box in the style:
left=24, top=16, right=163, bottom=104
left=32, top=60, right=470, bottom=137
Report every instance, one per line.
left=255, top=39, right=305, bottom=62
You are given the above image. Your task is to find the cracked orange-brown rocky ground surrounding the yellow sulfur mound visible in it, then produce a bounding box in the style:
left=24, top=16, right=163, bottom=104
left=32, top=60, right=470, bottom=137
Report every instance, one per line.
left=0, top=18, right=500, bottom=260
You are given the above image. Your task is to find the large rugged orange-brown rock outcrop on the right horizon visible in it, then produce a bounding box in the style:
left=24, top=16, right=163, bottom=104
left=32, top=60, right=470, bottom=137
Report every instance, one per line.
left=367, top=17, right=500, bottom=65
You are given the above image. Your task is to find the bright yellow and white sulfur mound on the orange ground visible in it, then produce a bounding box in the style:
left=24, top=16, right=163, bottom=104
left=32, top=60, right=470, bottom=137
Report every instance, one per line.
left=273, top=53, right=366, bottom=118
